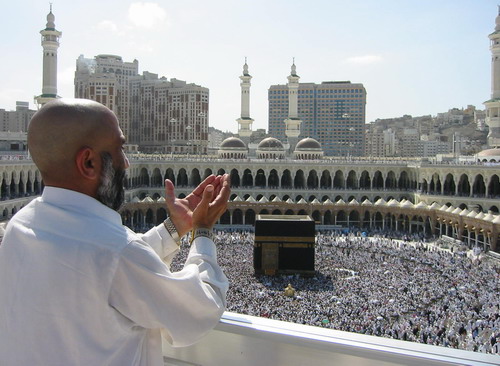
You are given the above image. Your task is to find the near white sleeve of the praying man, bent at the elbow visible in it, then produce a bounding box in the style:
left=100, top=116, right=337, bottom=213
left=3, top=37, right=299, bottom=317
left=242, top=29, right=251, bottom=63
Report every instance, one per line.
left=109, top=237, right=228, bottom=346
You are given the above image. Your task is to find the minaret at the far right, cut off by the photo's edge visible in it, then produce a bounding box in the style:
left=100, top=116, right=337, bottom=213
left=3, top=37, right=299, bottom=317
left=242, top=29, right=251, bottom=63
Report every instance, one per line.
left=483, top=6, right=500, bottom=148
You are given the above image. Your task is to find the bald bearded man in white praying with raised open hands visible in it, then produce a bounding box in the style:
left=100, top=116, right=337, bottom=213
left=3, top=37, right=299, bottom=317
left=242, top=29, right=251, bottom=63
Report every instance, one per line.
left=0, top=99, right=230, bottom=366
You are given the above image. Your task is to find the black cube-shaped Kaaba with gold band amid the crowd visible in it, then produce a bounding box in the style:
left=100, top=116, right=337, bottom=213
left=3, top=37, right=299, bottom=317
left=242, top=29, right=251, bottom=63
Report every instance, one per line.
left=253, top=215, right=316, bottom=276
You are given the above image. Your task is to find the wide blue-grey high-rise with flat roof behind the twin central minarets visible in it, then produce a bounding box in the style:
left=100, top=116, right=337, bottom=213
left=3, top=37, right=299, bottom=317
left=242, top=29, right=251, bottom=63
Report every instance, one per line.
left=268, top=76, right=366, bottom=156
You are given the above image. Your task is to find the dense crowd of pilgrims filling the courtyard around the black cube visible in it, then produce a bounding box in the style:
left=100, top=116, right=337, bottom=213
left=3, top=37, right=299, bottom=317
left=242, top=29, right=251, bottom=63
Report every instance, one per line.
left=172, top=231, right=500, bottom=354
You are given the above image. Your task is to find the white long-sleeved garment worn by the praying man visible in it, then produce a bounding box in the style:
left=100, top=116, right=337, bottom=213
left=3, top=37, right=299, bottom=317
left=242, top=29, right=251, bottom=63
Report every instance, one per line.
left=0, top=187, right=228, bottom=366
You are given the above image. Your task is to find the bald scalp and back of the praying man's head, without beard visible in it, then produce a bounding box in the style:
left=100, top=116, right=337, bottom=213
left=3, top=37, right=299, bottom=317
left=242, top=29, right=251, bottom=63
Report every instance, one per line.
left=28, top=99, right=121, bottom=186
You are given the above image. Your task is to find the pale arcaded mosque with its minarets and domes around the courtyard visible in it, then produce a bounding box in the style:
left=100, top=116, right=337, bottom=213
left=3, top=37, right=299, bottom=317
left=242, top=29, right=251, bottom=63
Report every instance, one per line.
left=0, top=7, right=500, bottom=252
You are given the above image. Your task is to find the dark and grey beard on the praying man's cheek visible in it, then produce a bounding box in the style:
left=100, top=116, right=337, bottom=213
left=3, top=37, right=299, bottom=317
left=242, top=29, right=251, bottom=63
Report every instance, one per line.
left=97, top=152, right=125, bottom=211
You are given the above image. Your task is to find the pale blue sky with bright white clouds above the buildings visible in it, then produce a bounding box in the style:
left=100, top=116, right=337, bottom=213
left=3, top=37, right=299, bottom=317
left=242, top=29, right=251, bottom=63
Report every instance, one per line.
left=0, top=0, right=498, bottom=132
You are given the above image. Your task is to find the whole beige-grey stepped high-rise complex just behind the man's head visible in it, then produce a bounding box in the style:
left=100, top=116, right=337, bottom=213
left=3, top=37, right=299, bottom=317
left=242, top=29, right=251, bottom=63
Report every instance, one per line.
left=75, top=55, right=209, bottom=154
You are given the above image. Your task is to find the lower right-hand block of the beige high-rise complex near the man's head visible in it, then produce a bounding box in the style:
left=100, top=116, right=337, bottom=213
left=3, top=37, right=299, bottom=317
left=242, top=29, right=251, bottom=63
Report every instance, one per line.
left=130, top=72, right=209, bottom=155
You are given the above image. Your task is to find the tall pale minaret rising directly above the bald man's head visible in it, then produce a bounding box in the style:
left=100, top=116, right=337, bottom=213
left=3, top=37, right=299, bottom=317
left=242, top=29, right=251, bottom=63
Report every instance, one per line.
left=35, top=4, right=62, bottom=107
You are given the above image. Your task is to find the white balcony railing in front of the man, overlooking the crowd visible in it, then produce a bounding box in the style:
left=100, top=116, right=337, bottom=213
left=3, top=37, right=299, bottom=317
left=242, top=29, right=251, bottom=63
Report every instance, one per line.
left=164, top=312, right=500, bottom=366
